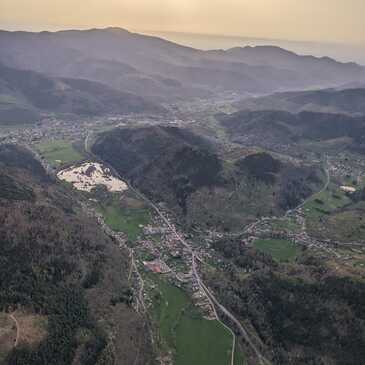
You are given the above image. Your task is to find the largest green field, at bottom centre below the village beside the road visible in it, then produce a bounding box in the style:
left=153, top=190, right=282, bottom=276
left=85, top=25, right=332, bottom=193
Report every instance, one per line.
left=150, top=277, right=232, bottom=365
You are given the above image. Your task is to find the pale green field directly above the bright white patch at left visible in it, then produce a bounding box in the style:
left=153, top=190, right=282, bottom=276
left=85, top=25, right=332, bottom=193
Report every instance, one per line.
left=36, top=140, right=84, bottom=166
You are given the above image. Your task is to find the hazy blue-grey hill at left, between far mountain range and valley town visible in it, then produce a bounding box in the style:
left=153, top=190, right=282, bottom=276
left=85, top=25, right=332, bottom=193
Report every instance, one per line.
left=0, top=65, right=163, bottom=123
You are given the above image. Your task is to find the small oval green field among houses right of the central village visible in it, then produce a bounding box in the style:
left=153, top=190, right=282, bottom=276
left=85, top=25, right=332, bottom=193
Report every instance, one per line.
left=254, top=239, right=300, bottom=262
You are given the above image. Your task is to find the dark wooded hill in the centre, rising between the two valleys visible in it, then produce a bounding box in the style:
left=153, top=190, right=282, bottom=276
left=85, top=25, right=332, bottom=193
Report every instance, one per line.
left=92, top=126, right=322, bottom=230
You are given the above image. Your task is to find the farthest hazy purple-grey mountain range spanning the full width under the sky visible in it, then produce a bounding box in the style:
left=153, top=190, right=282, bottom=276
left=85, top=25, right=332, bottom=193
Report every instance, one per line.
left=0, top=28, right=365, bottom=102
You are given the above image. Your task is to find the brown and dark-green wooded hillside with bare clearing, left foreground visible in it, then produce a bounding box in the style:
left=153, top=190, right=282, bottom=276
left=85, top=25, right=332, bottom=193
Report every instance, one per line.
left=0, top=145, right=151, bottom=365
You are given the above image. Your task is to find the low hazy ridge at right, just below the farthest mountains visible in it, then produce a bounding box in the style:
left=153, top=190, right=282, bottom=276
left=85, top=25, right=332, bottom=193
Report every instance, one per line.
left=235, top=85, right=365, bottom=115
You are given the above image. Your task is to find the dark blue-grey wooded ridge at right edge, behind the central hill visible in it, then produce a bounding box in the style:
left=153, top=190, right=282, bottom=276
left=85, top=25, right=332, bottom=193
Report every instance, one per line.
left=218, top=110, right=365, bottom=151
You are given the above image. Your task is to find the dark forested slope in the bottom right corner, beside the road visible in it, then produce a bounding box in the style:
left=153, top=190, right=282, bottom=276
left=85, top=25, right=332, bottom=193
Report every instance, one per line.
left=209, top=239, right=365, bottom=365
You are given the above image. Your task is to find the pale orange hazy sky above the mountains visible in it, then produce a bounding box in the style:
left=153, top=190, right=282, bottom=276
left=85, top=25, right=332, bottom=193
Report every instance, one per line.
left=0, top=0, right=365, bottom=45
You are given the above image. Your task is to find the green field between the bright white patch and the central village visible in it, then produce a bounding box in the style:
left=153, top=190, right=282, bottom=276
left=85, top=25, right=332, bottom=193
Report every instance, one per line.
left=99, top=201, right=150, bottom=241
